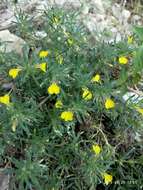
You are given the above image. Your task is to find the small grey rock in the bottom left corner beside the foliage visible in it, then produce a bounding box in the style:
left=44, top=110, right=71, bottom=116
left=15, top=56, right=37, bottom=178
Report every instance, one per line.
left=0, top=173, right=10, bottom=190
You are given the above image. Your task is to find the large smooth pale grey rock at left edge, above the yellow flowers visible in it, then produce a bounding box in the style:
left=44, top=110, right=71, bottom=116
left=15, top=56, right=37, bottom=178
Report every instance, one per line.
left=0, top=30, right=26, bottom=55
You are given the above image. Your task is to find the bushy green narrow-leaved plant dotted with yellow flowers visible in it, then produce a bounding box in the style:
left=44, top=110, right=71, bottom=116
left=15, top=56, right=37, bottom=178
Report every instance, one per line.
left=0, top=8, right=143, bottom=190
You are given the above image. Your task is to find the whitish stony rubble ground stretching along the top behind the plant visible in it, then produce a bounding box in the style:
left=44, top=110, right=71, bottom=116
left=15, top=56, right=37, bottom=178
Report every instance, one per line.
left=0, top=0, right=142, bottom=41
